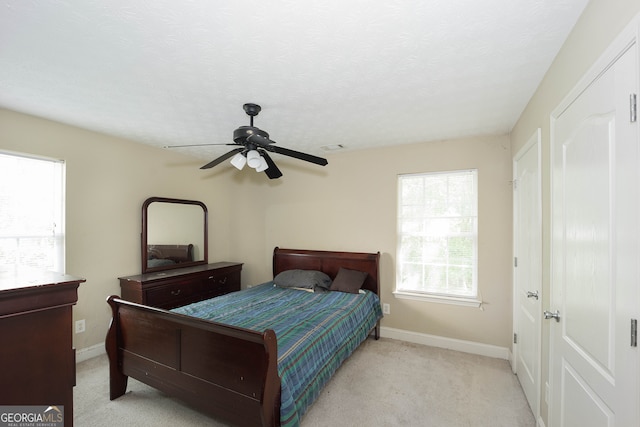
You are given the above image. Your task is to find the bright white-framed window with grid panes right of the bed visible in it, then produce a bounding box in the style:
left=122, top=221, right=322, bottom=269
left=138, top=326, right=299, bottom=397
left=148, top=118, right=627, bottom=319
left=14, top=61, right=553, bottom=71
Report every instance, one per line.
left=395, top=169, right=479, bottom=305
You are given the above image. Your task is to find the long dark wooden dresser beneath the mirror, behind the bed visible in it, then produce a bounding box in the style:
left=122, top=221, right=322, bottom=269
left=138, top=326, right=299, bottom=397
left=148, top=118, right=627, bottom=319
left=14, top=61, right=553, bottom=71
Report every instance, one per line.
left=119, top=262, right=242, bottom=309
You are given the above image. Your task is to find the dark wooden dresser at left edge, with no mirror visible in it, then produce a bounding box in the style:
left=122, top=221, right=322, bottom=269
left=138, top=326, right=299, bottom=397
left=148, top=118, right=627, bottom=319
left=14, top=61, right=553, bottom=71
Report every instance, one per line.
left=0, top=269, right=85, bottom=426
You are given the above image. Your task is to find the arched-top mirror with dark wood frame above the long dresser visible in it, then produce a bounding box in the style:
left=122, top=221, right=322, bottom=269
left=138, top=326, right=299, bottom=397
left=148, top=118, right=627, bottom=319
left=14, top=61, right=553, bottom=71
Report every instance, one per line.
left=142, top=197, right=208, bottom=273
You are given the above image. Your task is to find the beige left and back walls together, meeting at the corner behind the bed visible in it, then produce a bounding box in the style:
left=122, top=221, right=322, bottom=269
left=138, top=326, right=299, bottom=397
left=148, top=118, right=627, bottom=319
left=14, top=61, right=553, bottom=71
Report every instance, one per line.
left=0, top=110, right=511, bottom=349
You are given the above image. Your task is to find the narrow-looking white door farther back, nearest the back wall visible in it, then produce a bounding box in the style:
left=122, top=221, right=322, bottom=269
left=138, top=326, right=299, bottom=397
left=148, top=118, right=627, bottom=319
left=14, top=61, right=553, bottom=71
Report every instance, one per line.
left=513, top=129, right=542, bottom=418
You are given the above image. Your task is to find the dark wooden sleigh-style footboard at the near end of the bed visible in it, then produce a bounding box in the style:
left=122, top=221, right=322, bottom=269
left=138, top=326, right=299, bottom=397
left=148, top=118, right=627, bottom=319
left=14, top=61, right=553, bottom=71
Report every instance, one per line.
left=105, top=296, right=280, bottom=426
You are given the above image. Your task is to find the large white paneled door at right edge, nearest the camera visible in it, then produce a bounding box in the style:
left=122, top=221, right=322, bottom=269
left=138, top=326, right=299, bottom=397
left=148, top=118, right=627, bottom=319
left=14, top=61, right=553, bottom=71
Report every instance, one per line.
left=545, top=43, right=640, bottom=427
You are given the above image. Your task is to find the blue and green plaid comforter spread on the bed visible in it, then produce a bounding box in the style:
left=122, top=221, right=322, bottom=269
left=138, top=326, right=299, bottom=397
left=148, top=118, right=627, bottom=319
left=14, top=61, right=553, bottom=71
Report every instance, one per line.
left=172, top=282, right=382, bottom=426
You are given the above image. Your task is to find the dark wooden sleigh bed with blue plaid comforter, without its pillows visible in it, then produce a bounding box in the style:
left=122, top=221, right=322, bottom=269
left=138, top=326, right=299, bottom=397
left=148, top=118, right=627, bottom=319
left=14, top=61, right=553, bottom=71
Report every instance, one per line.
left=106, top=248, right=381, bottom=426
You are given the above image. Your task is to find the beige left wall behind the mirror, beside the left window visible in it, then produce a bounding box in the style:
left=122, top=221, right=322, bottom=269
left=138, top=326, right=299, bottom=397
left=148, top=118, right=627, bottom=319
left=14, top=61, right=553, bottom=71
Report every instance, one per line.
left=0, top=109, right=235, bottom=349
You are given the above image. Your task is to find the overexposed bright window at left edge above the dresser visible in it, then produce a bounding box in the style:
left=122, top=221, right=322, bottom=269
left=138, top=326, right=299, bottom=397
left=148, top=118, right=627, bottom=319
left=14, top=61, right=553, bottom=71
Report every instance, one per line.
left=0, top=152, right=64, bottom=273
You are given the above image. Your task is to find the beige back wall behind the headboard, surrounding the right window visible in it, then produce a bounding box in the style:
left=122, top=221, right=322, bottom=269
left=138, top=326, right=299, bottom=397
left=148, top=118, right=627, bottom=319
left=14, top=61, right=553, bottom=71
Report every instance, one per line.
left=231, top=136, right=512, bottom=347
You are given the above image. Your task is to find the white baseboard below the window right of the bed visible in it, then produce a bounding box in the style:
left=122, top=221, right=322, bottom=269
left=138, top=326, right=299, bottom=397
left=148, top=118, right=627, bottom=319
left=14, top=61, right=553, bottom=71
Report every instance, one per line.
left=380, top=326, right=510, bottom=360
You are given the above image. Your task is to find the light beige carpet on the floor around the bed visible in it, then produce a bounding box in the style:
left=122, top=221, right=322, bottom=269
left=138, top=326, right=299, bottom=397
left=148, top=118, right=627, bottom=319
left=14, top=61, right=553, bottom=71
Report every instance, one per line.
left=74, top=338, right=535, bottom=427
